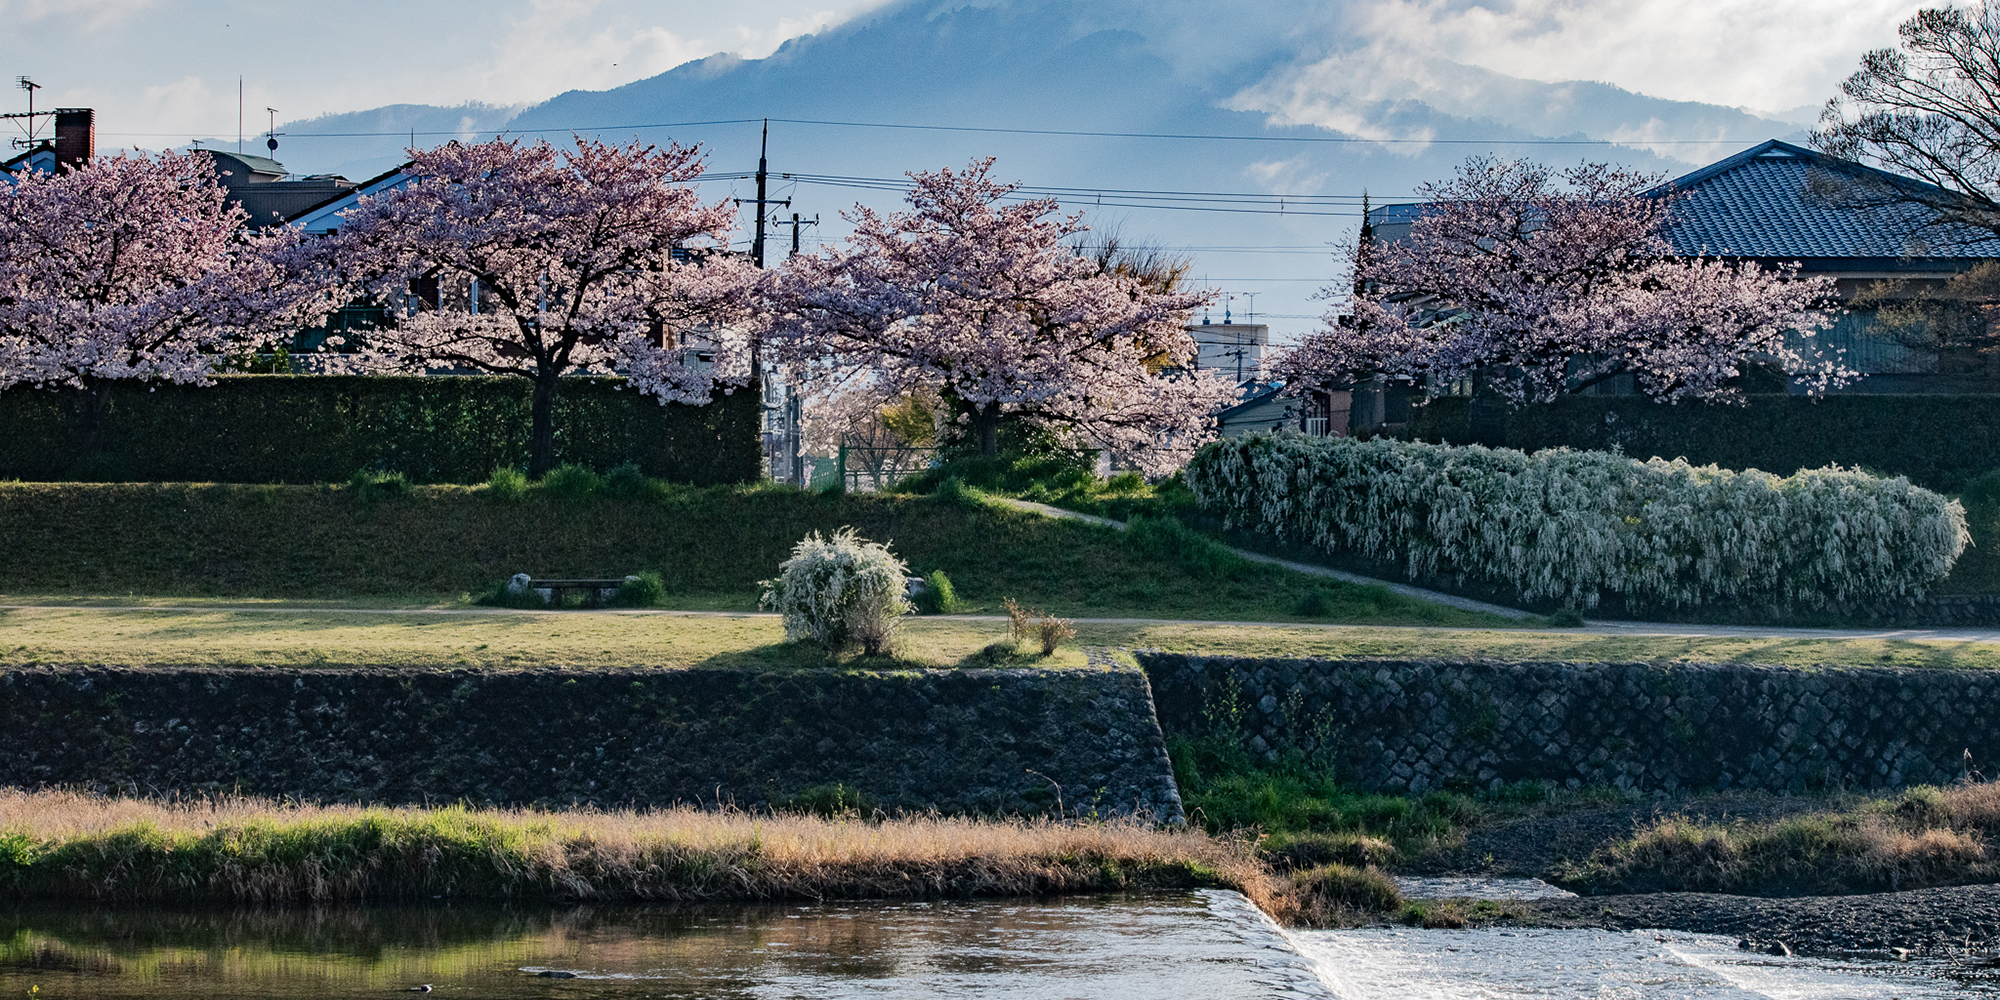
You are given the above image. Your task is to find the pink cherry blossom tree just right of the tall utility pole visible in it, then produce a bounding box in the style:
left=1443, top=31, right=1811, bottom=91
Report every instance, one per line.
left=768, top=158, right=1236, bottom=472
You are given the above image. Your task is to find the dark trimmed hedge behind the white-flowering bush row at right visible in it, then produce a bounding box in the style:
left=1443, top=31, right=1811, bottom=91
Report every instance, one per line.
left=1410, top=394, right=2000, bottom=492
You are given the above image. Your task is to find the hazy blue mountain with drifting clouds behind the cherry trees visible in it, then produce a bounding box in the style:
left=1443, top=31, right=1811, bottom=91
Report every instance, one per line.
left=242, top=0, right=1800, bottom=334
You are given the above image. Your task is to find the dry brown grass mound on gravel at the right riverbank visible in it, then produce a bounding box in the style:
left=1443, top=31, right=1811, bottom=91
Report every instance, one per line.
left=1558, top=782, right=2000, bottom=896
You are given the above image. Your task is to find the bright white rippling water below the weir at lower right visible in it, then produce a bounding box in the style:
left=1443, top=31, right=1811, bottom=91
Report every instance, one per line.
left=1294, top=928, right=2000, bottom=1000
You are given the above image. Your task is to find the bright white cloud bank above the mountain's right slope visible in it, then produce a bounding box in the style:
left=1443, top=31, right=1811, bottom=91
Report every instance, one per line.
left=1348, top=0, right=1924, bottom=108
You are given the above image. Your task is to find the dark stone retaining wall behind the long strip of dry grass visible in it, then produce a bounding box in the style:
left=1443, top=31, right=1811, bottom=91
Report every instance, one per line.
left=0, top=666, right=1182, bottom=820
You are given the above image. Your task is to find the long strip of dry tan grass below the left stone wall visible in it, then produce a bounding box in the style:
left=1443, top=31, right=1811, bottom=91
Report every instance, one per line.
left=0, top=790, right=1286, bottom=916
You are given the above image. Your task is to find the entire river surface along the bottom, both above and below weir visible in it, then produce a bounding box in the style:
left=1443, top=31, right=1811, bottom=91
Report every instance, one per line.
left=0, top=892, right=2000, bottom=1000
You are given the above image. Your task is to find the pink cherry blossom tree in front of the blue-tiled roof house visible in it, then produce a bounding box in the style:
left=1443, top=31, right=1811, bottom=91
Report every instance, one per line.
left=1270, top=158, right=1854, bottom=404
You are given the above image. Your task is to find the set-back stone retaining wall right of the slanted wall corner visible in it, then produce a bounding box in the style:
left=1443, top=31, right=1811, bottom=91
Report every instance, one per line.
left=1138, top=652, right=2000, bottom=794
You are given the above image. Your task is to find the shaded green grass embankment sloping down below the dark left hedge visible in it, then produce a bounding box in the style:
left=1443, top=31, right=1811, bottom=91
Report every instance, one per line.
left=0, top=484, right=1502, bottom=626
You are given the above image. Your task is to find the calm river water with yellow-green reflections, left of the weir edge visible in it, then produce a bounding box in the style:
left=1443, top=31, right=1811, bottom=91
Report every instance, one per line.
left=0, top=892, right=1326, bottom=1000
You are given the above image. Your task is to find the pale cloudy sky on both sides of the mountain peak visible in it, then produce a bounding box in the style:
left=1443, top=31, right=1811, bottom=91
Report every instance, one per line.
left=0, top=0, right=1920, bottom=148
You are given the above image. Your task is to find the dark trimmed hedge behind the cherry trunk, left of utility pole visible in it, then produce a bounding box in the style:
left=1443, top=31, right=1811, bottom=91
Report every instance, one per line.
left=0, top=376, right=760, bottom=486
